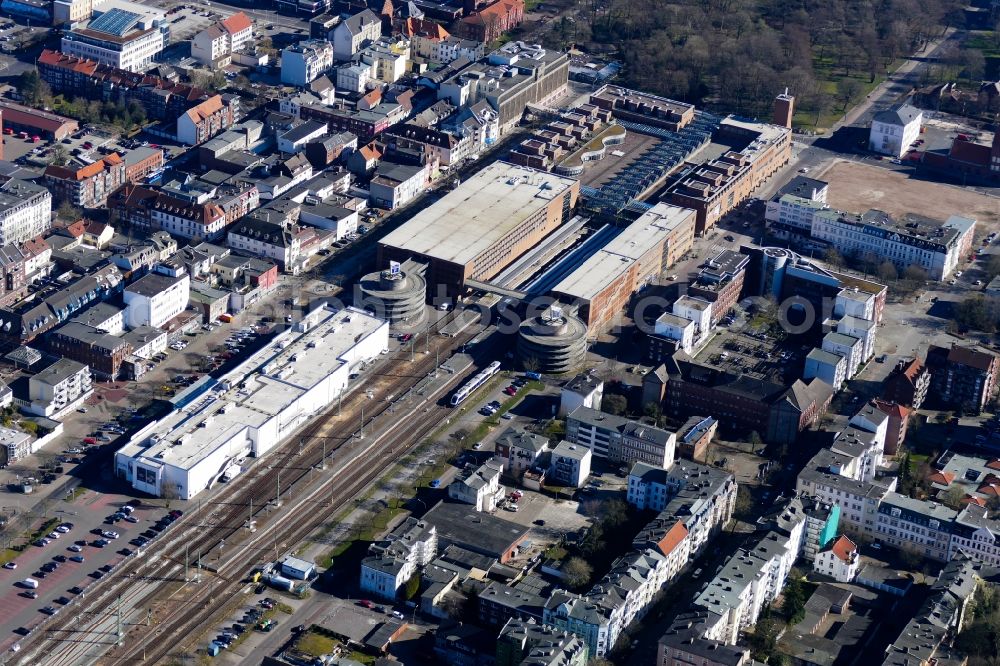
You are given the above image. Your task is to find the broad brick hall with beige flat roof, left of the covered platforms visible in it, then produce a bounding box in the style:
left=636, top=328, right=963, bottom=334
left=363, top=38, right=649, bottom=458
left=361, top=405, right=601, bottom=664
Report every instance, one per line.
left=378, top=162, right=580, bottom=295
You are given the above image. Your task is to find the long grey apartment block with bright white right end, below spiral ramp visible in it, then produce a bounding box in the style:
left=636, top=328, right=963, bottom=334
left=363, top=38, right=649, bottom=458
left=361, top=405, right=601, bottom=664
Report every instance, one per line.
left=566, top=407, right=677, bottom=469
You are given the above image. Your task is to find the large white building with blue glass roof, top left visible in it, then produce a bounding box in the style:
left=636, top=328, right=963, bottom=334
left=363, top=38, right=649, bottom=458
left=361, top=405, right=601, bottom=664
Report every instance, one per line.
left=60, top=8, right=168, bottom=72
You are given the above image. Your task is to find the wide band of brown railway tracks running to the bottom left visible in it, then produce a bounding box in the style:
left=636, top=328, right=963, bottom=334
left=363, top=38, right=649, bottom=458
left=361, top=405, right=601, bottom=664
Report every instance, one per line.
left=11, top=313, right=488, bottom=666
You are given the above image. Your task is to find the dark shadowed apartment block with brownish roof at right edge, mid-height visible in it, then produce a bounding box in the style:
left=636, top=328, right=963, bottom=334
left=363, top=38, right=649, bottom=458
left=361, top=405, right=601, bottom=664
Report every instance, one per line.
left=924, top=343, right=1000, bottom=412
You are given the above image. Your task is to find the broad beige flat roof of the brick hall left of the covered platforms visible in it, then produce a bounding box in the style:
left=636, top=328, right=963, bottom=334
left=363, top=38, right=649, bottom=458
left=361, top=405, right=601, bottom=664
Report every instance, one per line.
left=380, top=162, right=576, bottom=265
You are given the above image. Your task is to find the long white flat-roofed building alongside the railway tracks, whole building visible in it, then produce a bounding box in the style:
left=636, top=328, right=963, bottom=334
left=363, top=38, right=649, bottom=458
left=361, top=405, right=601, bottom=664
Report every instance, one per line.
left=115, top=307, right=389, bottom=499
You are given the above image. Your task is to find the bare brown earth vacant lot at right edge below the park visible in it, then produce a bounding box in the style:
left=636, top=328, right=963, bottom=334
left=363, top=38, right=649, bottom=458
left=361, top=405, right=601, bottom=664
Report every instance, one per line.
left=817, top=160, right=1000, bottom=223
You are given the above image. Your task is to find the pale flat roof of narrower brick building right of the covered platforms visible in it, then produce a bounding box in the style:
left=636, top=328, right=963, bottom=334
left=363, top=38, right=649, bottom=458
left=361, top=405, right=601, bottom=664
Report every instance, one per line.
left=552, top=203, right=695, bottom=300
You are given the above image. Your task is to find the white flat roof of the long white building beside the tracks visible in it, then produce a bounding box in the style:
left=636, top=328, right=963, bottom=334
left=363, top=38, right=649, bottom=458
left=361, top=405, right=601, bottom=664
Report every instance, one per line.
left=118, top=308, right=385, bottom=471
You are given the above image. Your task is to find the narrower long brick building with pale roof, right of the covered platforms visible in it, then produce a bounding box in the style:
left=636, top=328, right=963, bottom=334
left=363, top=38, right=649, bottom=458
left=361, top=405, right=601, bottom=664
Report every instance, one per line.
left=552, top=203, right=696, bottom=332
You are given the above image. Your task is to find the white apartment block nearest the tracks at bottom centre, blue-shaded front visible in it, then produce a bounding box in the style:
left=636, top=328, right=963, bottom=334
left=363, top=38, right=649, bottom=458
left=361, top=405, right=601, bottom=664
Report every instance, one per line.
left=360, top=517, right=437, bottom=601
